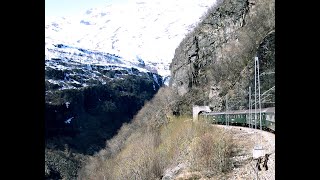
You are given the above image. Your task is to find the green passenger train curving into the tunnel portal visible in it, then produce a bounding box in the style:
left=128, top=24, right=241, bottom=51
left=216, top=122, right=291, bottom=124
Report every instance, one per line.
left=199, top=107, right=276, bottom=133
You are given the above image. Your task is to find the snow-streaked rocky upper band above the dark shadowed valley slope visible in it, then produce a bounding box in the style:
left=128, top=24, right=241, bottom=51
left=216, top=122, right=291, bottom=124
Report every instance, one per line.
left=45, top=44, right=162, bottom=91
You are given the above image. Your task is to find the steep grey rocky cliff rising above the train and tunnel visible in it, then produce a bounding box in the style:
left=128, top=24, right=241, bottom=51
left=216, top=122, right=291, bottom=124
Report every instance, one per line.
left=170, top=0, right=275, bottom=112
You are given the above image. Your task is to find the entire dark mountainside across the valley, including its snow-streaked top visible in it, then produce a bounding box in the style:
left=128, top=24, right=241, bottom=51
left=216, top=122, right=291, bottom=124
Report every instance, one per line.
left=45, top=44, right=164, bottom=154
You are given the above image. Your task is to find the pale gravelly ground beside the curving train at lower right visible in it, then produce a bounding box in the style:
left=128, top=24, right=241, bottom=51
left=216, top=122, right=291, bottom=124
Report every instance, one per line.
left=217, top=125, right=275, bottom=180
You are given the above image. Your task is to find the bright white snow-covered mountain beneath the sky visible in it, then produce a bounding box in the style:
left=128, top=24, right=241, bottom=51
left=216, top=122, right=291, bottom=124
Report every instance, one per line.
left=45, top=0, right=216, bottom=77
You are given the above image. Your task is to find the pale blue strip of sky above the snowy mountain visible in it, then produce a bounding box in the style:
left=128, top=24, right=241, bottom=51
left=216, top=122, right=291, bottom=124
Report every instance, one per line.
left=45, top=0, right=128, bottom=17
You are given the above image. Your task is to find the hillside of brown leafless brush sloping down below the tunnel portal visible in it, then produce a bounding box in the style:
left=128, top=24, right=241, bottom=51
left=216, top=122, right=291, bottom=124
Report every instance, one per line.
left=79, top=88, right=233, bottom=180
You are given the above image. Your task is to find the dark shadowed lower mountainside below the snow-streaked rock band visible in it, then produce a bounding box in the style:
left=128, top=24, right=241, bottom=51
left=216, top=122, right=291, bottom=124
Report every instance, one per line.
left=45, top=86, right=157, bottom=155
